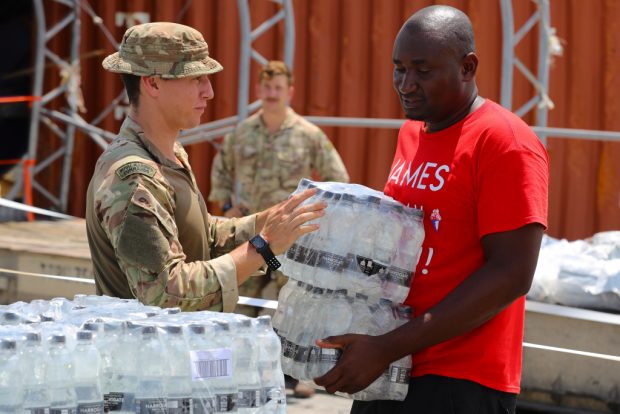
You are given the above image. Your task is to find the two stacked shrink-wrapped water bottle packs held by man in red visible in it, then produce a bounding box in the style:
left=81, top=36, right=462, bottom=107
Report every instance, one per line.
left=273, top=179, right=424, bottom=400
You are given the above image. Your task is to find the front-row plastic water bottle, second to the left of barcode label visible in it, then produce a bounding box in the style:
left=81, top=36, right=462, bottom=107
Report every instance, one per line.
left=135, top=326, right=168, bottom=414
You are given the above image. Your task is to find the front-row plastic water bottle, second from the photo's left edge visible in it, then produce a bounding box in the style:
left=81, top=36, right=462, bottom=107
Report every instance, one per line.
left=21, top=332, right=50, bottom=414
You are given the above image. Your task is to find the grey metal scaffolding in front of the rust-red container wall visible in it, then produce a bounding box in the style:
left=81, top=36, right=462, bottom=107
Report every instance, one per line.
left=6, top=0, right=620, bottom=212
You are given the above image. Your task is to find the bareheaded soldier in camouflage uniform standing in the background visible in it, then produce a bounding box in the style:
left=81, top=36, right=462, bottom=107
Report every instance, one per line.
left=209, top=61, right=349, bottom=316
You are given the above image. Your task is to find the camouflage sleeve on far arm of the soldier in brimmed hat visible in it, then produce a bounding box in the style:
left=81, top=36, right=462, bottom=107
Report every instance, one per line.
left=208, top=214, right=256, bottom=257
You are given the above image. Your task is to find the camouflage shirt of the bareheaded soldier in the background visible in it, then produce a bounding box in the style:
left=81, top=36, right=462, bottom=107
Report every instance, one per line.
left=209, top=108, right=349, bottom=213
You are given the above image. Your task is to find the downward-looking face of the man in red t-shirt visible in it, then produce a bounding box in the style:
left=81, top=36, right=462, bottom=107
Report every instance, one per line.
left=392, top=30, right=466, bottom=123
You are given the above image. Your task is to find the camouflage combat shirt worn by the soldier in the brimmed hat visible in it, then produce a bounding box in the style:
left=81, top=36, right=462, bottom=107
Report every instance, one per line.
left=86, top=117, right=256, bottom=311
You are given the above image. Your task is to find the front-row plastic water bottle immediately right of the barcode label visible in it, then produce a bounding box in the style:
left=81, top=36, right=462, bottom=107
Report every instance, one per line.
left=233, top=315, right=262, bottom=414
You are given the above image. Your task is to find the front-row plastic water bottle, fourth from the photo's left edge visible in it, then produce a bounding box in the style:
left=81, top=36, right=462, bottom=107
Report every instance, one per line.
left=73, top=330, right=103, bottom=414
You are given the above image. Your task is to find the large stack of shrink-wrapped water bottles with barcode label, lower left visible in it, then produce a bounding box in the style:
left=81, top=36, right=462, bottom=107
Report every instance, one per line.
left=0, top=295, right=286, bottom=414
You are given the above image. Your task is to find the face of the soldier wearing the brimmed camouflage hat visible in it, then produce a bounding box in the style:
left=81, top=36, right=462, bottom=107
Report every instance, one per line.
left=158, top=75, right=214, bottom=130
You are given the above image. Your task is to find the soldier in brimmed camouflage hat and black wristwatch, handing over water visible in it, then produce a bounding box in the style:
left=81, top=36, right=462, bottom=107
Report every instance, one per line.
left=86, top=23, right=325, bottom=311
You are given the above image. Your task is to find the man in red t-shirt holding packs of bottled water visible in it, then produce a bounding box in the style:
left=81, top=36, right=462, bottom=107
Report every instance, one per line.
left=315, top=6, right=548, bottom=414
